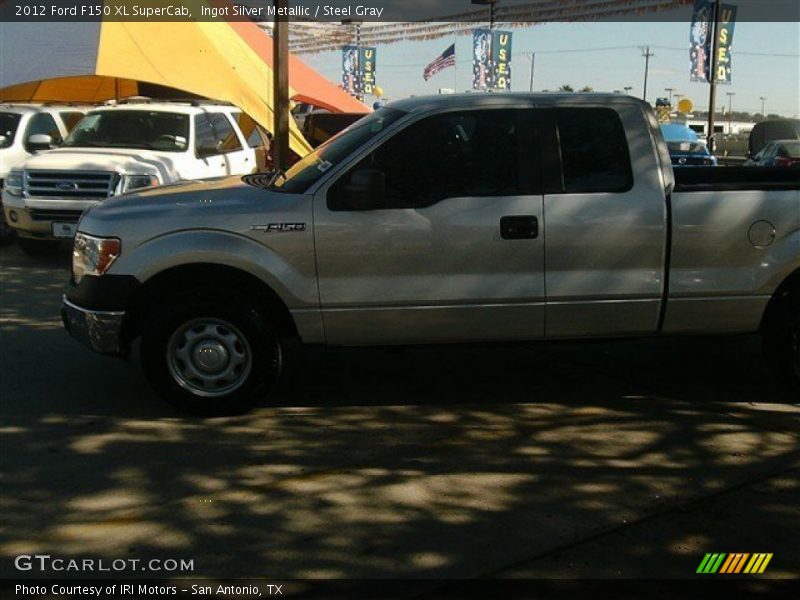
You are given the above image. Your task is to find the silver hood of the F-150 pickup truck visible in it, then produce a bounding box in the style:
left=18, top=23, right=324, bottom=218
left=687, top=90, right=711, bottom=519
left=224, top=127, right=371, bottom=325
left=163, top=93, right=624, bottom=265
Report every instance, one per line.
left=78, top=176, right=306, bottom=243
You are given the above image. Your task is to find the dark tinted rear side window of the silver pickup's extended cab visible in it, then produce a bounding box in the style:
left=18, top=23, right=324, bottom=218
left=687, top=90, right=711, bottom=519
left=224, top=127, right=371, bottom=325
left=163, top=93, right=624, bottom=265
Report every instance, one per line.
left=556, top=107, right=633, bottom=194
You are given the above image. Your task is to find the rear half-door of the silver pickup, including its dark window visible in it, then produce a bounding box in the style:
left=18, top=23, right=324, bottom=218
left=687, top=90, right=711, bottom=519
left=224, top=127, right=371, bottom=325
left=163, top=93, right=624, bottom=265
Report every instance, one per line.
left=540, top=106, right=666, bottom=337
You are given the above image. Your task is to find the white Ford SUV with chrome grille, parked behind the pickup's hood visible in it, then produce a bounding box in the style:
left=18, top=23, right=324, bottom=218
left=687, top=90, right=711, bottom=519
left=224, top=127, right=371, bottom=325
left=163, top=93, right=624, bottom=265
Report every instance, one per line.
left=3, top=100, right=267, bottom=254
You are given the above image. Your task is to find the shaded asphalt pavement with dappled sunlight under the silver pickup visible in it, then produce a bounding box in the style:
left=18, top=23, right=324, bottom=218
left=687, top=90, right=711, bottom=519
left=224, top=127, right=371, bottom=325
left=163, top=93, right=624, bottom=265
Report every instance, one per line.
left=0, top=241, right=800, bottom=578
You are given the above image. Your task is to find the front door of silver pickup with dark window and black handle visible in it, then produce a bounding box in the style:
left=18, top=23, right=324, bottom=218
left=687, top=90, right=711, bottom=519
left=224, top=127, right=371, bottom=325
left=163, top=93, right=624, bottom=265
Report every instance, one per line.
left=315, top=109, right=544, bottom=344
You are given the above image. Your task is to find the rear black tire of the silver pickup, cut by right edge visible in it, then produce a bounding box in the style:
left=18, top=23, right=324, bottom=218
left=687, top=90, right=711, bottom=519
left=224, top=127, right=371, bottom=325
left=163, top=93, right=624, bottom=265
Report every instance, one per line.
left=762, top=289, right=800, bottom=399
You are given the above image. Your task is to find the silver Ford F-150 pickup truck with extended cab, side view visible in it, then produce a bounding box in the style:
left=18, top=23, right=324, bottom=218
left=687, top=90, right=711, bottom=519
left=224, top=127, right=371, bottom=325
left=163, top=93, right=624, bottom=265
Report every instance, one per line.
left=63, top=94, right=800, bottom=413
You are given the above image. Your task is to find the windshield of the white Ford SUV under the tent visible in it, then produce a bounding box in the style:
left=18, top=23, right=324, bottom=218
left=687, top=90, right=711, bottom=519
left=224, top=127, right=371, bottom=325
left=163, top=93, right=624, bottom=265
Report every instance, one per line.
left=62, top=110, right=189, bottom=152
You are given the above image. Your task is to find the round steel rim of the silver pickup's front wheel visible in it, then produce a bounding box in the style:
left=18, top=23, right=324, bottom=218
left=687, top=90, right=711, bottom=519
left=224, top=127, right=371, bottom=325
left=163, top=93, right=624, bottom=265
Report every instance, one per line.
left=167, top=317, right=253, bottom=398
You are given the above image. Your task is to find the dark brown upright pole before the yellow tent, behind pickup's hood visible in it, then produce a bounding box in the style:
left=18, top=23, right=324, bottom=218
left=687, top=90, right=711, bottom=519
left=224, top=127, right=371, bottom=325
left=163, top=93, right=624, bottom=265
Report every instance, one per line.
left=272, top=0, right=289, bottom=169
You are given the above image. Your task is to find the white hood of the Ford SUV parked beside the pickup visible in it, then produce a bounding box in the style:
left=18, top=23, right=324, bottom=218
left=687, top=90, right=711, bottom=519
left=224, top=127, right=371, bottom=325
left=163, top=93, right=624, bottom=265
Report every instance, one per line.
left=25, top=148, right=180, bottom=183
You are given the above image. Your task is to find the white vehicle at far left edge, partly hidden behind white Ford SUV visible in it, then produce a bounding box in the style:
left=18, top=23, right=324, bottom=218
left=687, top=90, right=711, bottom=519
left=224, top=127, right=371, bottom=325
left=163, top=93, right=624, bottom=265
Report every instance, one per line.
left=0, top=104, right=88, bottom=244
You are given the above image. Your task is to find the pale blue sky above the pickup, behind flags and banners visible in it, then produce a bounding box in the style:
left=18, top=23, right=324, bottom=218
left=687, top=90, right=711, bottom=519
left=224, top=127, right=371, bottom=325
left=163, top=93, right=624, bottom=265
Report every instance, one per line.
left=301, top=22, right=800, bottom=118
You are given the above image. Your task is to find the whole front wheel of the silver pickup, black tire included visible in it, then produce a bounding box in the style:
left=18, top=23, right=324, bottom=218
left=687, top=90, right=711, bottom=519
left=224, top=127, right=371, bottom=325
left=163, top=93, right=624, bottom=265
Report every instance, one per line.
left=141, top=290, right=283, bottom=416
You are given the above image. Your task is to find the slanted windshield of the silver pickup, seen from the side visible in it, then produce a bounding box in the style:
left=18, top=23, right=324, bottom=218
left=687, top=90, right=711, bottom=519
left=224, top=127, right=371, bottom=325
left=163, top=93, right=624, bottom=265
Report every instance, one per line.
left=275, top=108, right=406, bottom=194
